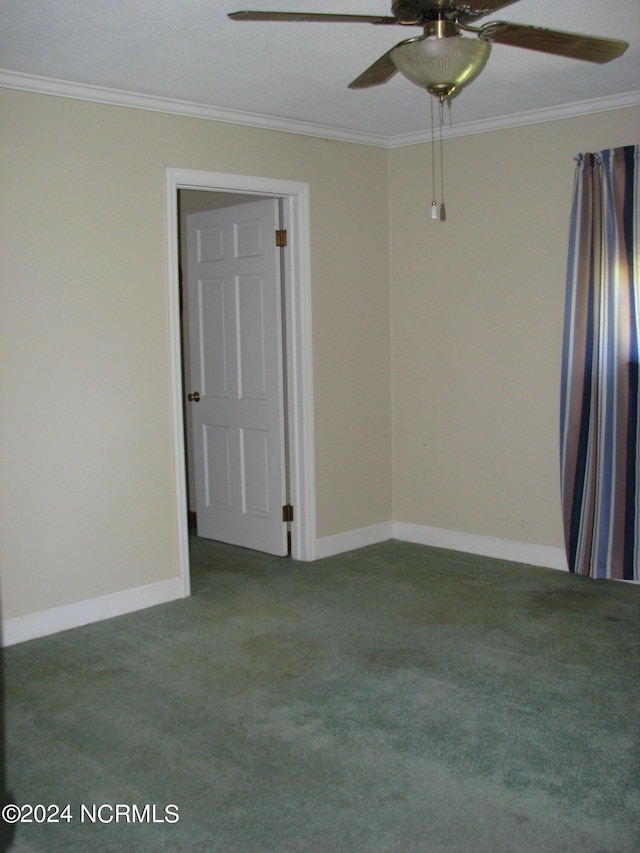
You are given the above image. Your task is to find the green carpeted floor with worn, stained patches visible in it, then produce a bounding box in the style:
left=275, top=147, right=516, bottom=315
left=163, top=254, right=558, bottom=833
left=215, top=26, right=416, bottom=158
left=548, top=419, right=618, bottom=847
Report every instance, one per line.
left=4, top=539, right=640, bottom=853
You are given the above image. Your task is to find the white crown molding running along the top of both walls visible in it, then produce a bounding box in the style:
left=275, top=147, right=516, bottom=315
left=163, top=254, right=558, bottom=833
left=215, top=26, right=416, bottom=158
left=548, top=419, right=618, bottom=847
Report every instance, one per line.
left=0, top=69, right=640, bottom=148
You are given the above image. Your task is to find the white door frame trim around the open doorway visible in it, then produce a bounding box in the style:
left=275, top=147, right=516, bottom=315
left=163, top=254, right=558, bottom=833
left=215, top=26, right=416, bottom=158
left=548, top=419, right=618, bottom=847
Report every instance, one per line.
left=166, top=168, right=316, bottom=596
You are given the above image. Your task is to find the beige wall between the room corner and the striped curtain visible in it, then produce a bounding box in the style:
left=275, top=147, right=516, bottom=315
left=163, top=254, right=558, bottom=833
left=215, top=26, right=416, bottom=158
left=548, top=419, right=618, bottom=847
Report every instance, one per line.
left=389, top=108, right=640, bottom=547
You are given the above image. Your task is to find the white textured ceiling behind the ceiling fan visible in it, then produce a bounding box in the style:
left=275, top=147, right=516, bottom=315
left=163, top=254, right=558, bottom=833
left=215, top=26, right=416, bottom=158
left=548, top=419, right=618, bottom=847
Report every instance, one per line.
left=0, top=0, right=640, bottom=140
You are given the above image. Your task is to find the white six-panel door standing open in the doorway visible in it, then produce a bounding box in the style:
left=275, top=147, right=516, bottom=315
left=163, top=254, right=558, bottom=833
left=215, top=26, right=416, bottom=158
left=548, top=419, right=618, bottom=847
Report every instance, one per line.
left=186, top=198, right=287, bottom=555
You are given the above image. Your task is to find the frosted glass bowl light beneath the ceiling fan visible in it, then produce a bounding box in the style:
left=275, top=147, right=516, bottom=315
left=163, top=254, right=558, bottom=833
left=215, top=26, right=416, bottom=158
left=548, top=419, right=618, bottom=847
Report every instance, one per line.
left=391, top=20, right=491, bottom=101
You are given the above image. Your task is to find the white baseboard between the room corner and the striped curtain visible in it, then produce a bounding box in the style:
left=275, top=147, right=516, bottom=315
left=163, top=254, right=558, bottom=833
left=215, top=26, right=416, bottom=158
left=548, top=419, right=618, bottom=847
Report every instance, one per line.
left=392, top=521, right=568, bottom=571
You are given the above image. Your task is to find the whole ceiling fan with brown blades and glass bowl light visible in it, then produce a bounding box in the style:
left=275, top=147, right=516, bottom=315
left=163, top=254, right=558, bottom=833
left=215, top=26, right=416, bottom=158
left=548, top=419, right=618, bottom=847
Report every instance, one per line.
left=229, top=0, right=629, bottom=103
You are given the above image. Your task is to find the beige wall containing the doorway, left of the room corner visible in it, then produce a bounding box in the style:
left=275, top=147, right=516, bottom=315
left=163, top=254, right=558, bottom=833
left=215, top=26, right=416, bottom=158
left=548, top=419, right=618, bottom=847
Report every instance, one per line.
left=0, top=90, right=391, bottom=617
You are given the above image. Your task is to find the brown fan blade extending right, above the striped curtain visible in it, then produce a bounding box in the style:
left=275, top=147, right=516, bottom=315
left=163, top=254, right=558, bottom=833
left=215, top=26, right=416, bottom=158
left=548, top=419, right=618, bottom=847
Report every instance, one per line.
left=481, top=21, right=629, bottom=63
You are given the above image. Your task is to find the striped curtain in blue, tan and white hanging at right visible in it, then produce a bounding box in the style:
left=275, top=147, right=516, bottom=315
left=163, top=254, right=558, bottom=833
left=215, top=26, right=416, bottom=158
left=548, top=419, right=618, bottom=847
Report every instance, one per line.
left=560, top=145, right=640, bottom=580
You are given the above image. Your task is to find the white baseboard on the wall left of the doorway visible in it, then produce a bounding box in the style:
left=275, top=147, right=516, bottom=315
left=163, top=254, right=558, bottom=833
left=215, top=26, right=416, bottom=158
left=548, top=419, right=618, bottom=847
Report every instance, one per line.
left=2, top=577, right=185, bottom=646
